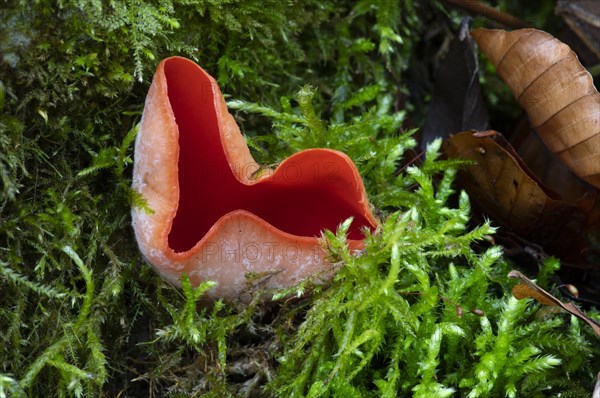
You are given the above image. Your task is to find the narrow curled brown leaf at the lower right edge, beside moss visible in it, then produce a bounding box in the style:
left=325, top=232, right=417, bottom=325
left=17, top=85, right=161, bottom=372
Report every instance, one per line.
left=508, top=270, right=600, bottom=336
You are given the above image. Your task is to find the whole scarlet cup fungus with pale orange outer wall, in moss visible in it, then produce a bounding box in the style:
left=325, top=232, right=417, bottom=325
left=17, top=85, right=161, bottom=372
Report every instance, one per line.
left=132, top=57, right=376, bottom=297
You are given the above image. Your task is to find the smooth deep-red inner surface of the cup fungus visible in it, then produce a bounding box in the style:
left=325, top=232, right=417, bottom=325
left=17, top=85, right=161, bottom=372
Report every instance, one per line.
left=165, top=62, right=373, bottom=252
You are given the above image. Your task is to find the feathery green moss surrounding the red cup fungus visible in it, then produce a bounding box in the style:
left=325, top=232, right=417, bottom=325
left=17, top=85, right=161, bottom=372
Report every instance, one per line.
left=0, top=0, right=600, bottom=397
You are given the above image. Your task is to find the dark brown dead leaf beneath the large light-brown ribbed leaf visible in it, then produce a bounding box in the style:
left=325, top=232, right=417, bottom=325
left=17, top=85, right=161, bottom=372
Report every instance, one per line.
left=444, top=131, right=598, bottom=258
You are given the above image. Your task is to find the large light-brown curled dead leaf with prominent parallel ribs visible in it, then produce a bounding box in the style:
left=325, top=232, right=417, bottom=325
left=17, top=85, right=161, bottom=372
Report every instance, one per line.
left=471, top=29, right=600, bottom=187
